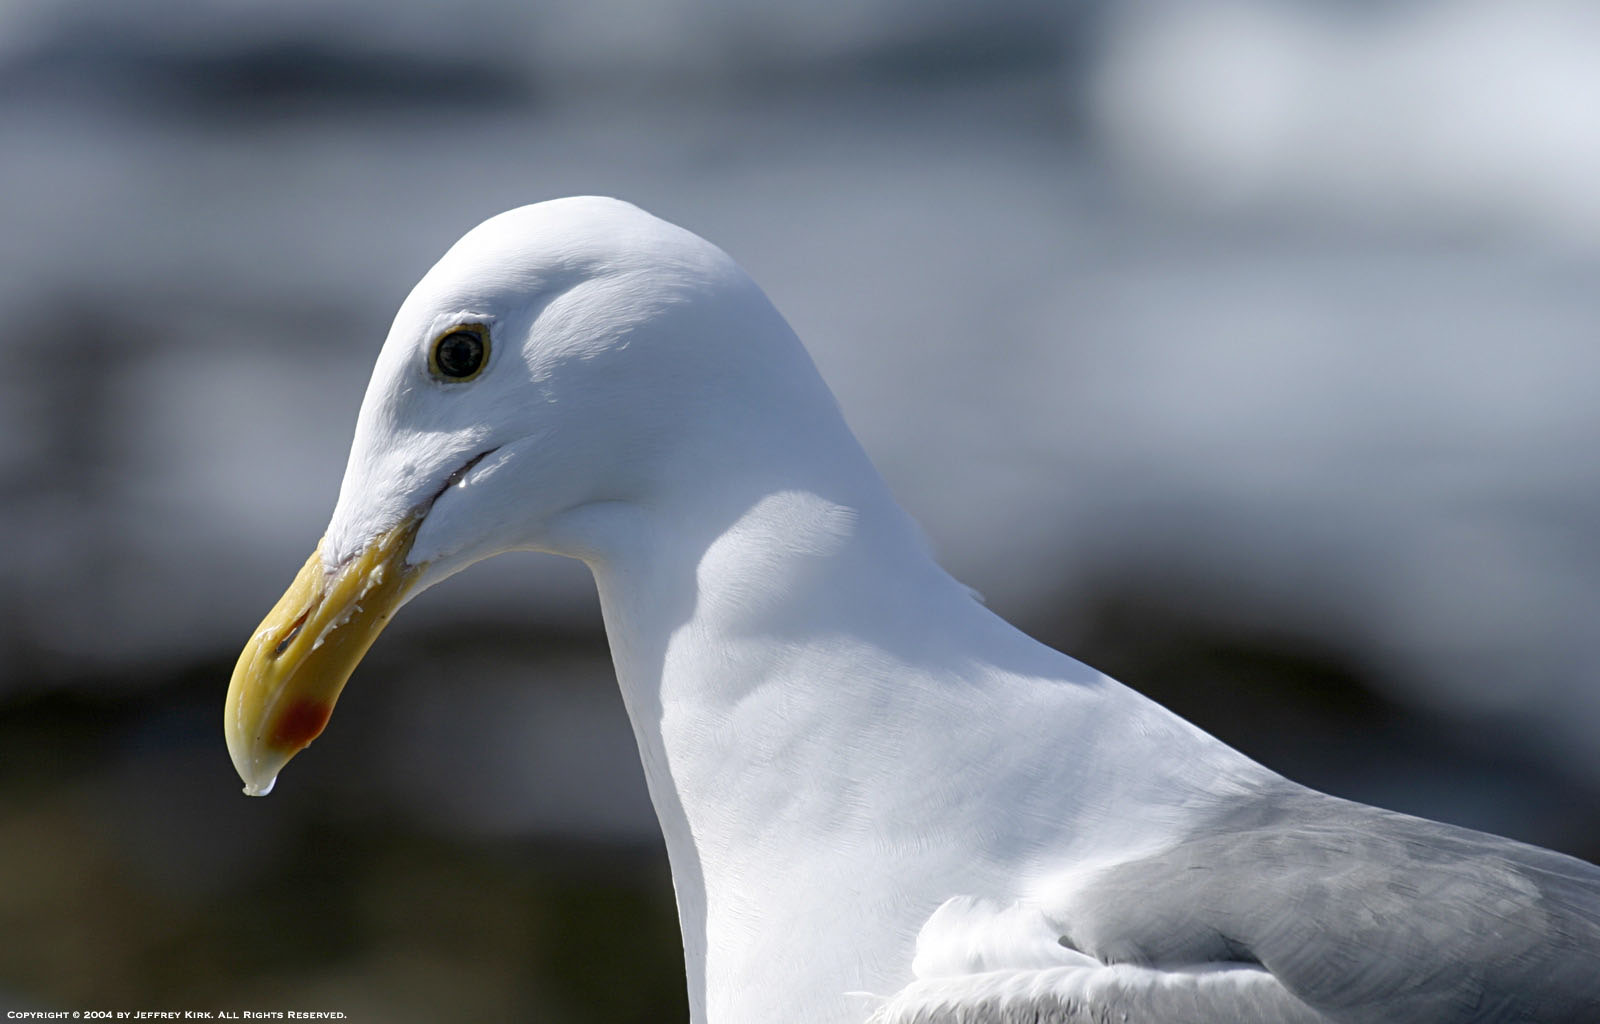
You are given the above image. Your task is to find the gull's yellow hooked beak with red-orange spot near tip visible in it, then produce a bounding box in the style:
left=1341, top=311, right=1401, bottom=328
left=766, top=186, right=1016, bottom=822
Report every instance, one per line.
left=222, top=515, right=422, bottom=797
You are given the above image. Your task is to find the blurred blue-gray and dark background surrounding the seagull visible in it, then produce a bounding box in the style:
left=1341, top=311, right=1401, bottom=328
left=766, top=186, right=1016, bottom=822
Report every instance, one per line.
left=0, top=0, right=1600, bottom=1024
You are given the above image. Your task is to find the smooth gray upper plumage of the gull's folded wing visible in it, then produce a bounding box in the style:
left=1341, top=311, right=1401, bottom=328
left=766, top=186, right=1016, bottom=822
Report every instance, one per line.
left=1056, top=781, right=1600, bottom=1024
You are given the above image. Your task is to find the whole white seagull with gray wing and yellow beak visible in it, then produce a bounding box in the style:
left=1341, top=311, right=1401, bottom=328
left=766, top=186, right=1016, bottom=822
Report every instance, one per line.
left=224, top=197, right=1600, bottom=1024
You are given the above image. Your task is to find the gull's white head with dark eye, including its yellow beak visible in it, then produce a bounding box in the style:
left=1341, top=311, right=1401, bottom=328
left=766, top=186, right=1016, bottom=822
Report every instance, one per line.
left=226, top=198, right=826, bottom=794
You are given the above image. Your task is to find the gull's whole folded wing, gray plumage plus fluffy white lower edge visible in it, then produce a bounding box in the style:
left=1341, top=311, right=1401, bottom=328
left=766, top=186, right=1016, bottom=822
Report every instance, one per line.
left=870, top=779, right=1600, bottom=1024
